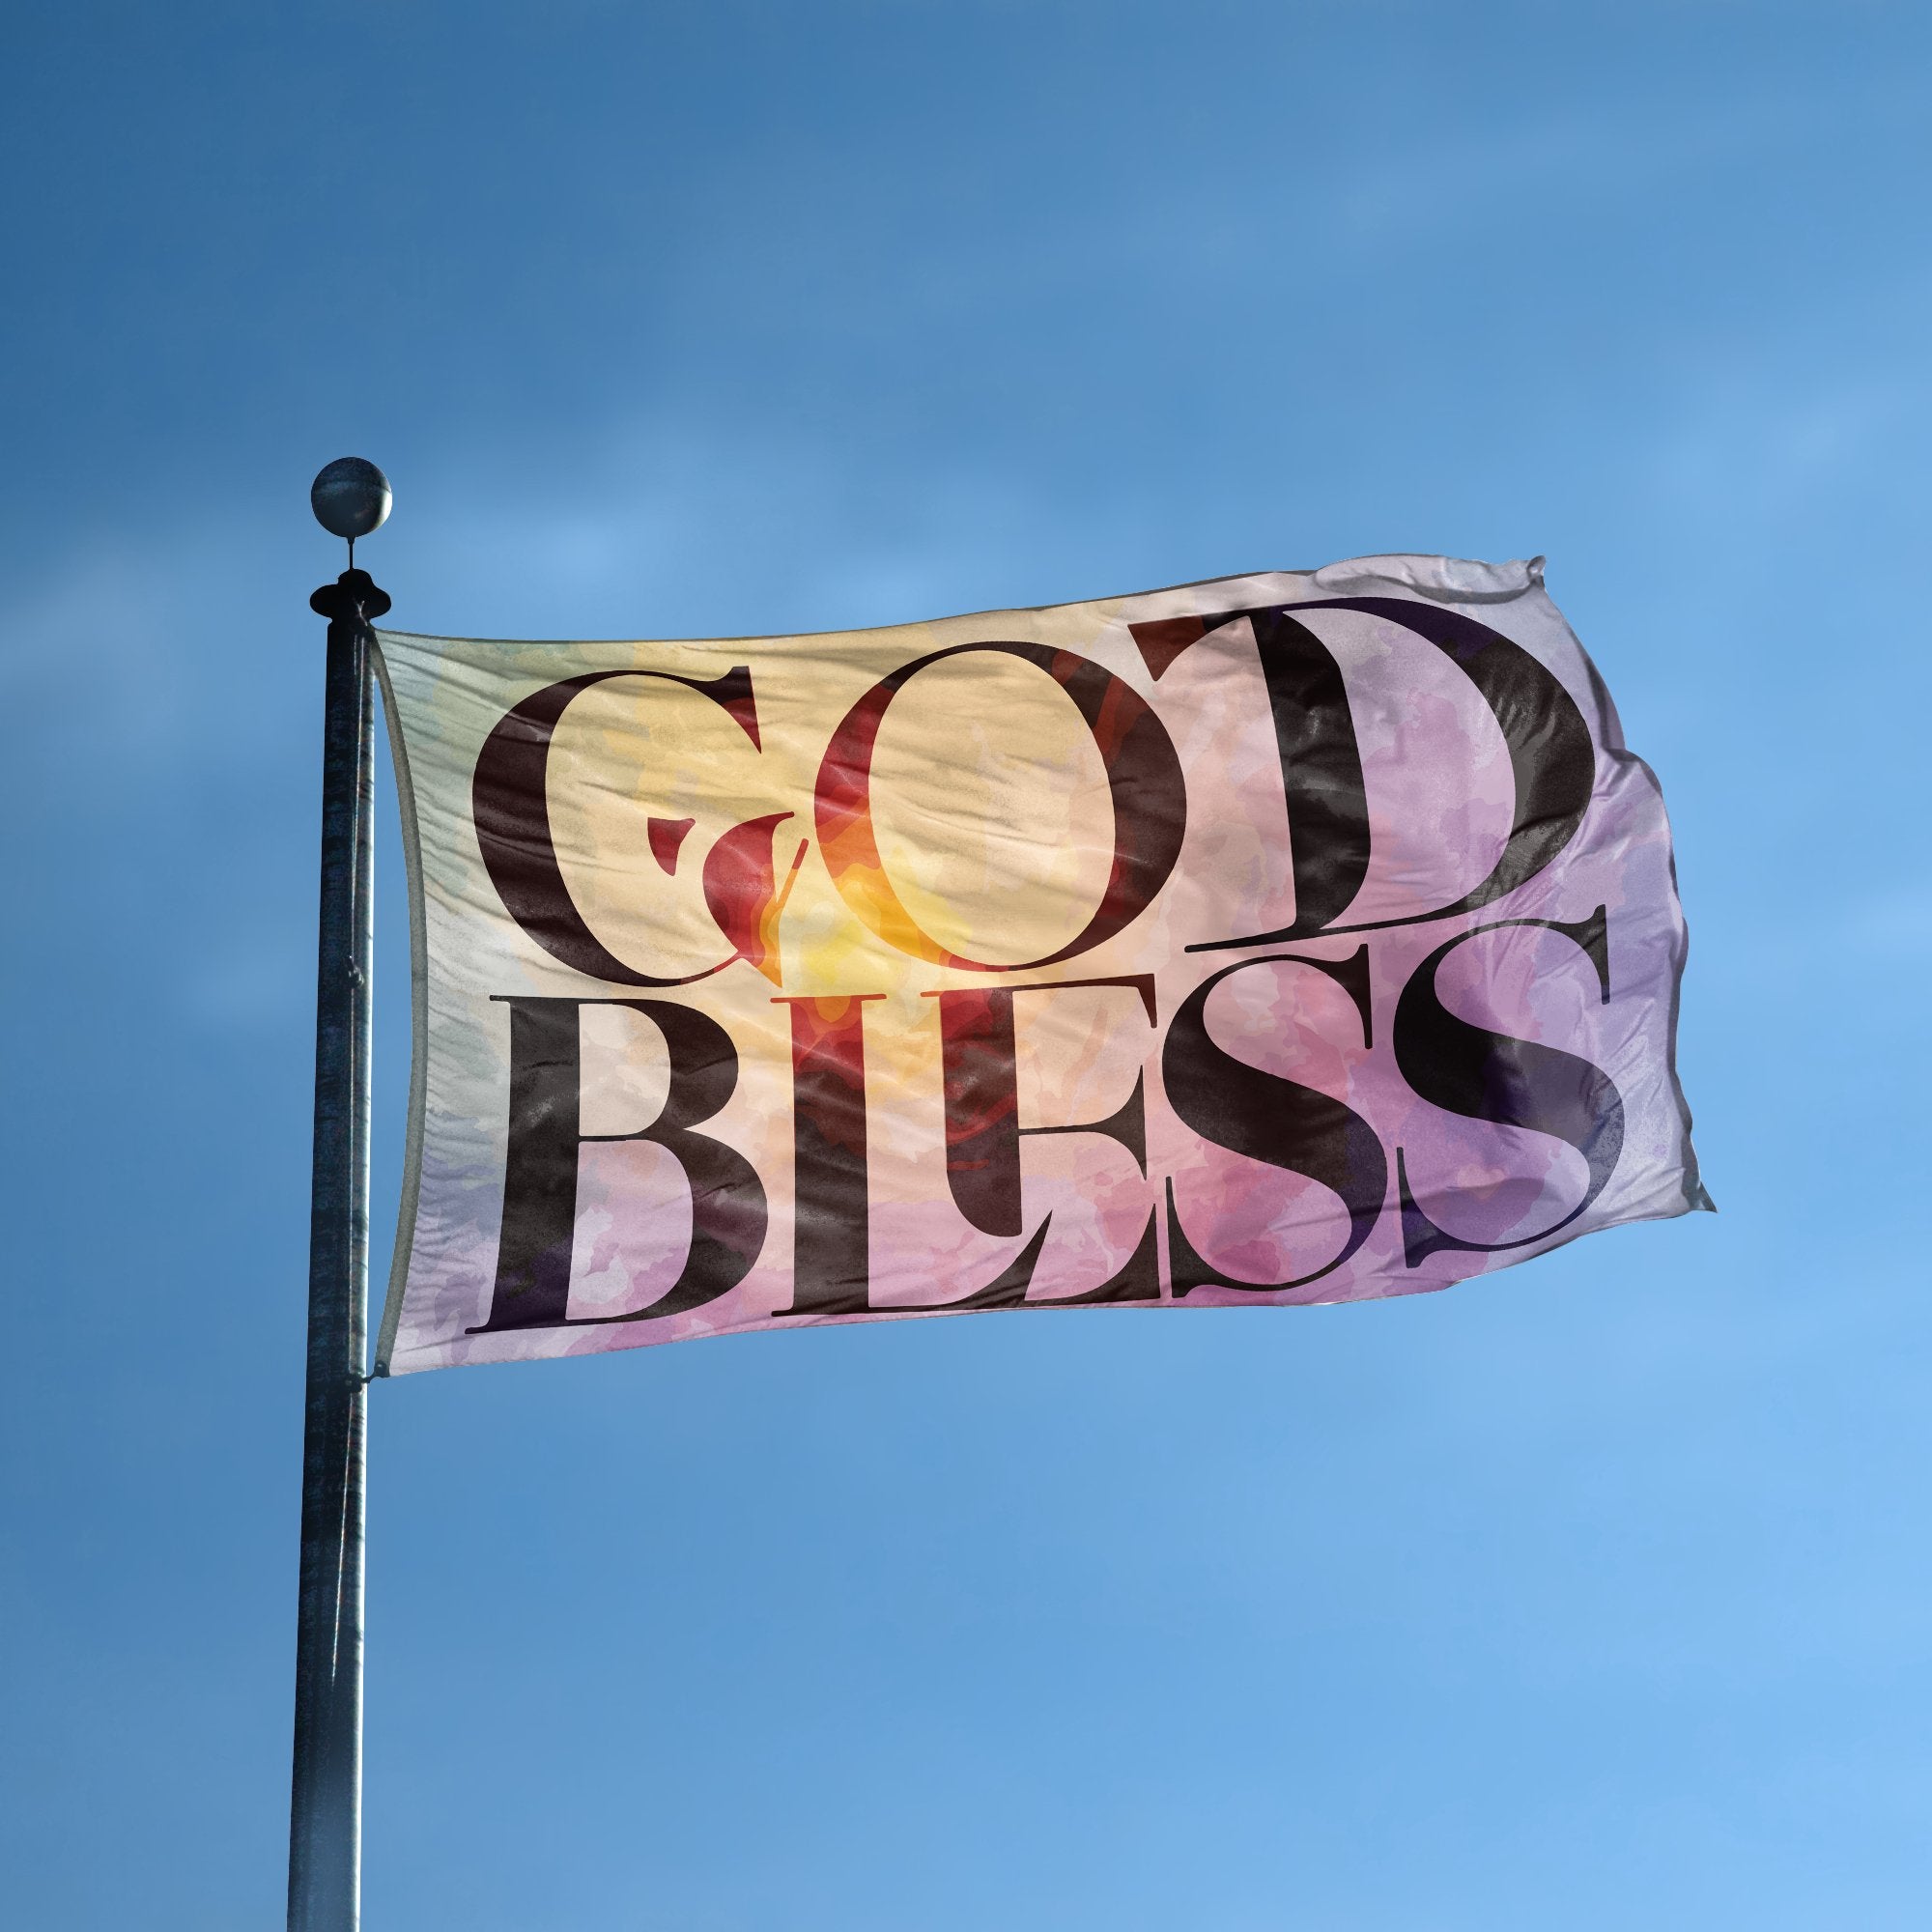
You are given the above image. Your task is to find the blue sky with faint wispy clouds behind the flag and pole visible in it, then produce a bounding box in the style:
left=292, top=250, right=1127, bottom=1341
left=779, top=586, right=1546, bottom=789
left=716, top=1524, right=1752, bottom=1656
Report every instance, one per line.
left=0, top=0, right=1932, bottom=1932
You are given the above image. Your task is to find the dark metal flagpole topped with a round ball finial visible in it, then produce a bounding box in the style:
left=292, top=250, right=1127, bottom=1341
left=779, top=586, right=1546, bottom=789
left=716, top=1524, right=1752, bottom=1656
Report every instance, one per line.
left=288, top=456, right=390, bottom=1932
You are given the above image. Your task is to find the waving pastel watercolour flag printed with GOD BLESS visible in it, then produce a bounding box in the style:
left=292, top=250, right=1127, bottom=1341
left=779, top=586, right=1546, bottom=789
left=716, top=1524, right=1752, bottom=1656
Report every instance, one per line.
left=379, top=556, right=1710, bottom=1374
